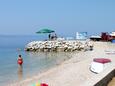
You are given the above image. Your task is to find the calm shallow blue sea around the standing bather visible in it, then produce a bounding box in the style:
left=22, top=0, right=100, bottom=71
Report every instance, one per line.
left=0, top=35, right=72, bottom=86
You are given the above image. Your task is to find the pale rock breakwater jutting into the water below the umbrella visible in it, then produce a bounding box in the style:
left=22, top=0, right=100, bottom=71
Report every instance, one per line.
left=25, top=40, right=93, bottom=52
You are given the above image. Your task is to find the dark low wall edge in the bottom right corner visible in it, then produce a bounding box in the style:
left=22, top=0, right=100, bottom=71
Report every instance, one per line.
left=94, top=69, right=115, bottom=86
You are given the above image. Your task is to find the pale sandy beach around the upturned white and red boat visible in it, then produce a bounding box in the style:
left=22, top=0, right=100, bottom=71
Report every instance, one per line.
left=9, top=42, right=115, bottom=86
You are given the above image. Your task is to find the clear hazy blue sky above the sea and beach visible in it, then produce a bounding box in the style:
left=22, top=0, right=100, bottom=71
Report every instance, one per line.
left=0, top=0, right=115, bottom=36
